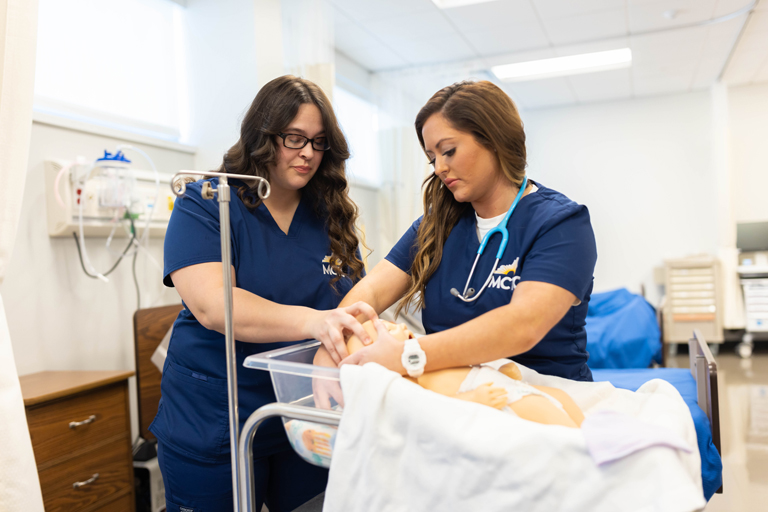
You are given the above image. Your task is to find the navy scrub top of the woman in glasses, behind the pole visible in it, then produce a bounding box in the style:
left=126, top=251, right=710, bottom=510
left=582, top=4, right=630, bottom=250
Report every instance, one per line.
left=150, top=178, right=352, bottom=462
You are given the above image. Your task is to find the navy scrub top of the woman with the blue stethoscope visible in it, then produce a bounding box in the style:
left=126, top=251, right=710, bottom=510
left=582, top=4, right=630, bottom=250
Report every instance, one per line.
left=386, top=183, right=597, bottom=380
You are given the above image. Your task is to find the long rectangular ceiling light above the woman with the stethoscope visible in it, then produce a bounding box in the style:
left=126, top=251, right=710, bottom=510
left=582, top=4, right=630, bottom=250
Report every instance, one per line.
left=491, top=48, right=632, bottom=82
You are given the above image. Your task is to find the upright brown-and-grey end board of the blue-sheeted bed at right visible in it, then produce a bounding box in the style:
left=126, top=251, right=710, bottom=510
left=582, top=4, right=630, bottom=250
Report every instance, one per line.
left=688, top=329, right=723, bottom=457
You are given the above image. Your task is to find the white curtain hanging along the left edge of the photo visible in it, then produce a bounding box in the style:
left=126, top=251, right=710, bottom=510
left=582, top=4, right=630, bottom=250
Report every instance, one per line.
left=0, top=0, right=43, bottom=512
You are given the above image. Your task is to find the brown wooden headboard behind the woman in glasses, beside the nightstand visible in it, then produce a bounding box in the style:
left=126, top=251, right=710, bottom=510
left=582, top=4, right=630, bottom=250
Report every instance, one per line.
left=133, top=304, right=183, bottom=440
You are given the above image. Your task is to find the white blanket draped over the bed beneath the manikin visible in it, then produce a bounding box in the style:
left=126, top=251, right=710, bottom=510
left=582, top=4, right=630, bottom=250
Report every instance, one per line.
left=323, top=363, right=706, bottom=512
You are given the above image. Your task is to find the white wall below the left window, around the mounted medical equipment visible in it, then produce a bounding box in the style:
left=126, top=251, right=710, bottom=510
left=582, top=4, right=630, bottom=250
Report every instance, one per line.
left=0, top=123, right=194, bottom=433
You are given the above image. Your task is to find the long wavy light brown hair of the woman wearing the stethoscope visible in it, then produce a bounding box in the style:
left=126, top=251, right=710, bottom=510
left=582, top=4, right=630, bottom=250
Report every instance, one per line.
left=396, top=81, right=526, bottom=314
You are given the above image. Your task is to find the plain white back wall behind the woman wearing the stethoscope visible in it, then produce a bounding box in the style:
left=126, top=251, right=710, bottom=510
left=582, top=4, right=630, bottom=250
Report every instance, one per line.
left=523, top=92, right=717, bottom=303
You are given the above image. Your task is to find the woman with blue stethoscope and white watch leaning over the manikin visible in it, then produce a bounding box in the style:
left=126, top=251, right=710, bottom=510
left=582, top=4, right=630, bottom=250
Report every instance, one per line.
left=316, top=81, right=597, bottom=381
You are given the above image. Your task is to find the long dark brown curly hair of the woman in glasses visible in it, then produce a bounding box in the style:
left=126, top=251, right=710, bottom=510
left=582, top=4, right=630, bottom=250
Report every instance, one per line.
left=213, top=75, right=364, bottom=290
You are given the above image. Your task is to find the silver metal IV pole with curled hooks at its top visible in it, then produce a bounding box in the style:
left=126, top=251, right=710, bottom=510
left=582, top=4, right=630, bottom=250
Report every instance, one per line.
left=171, top=171, right=271, bottom=512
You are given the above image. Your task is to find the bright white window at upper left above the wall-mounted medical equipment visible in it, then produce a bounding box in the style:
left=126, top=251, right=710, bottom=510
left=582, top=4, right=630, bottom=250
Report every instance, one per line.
left=35, top=0, right=188, bottom=141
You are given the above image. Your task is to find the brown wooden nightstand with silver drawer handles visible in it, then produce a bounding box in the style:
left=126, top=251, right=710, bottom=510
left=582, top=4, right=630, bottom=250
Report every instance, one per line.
left=19, top=371, right=136, bottom=512
